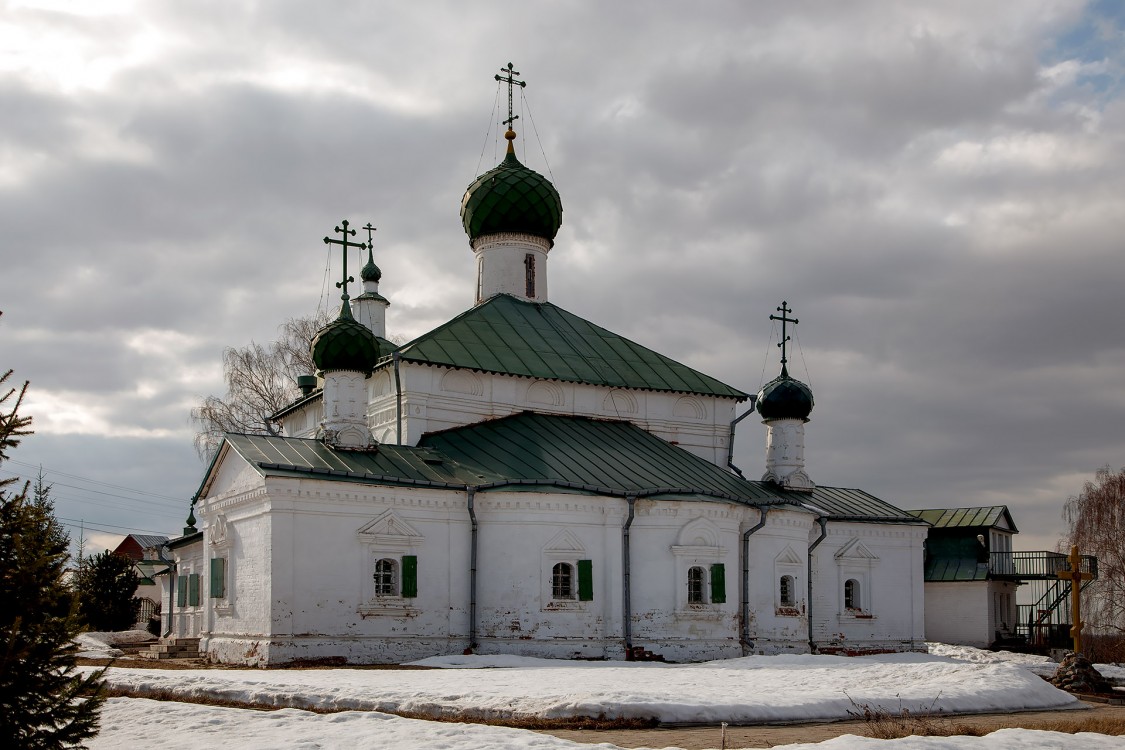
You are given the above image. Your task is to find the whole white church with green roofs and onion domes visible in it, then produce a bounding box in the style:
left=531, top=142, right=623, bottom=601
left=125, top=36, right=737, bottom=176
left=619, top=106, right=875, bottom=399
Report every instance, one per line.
left=163, top=76, right=928, bottom=666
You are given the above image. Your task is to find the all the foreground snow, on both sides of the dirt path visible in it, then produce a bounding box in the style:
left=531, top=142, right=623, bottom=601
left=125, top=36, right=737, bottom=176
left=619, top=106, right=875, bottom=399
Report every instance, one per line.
left=79, top=644, right=1125, bottom=750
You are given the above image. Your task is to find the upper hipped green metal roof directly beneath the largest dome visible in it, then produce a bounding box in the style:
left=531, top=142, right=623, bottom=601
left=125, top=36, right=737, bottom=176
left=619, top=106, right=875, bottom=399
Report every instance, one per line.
left=380, top=295, right=748, bottom=400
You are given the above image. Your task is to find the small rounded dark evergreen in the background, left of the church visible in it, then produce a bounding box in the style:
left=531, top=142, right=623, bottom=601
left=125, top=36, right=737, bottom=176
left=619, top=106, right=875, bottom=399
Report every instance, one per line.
left=74, top=550, right=141, bottom=632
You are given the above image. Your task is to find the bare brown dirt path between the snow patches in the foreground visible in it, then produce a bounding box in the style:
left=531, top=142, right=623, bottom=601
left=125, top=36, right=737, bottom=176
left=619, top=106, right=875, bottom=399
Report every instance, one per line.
left=533, top=702, right=1125, bottom=750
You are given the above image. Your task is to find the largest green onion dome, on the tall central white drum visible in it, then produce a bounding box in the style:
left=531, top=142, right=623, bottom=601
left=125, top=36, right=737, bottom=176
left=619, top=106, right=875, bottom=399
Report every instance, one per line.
left=461, top=130, right=563, bottom=241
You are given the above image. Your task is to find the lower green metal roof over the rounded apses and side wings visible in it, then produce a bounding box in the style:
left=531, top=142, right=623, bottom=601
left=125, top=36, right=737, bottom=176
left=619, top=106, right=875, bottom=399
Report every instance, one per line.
left=198, top=412, right=920, bottom=524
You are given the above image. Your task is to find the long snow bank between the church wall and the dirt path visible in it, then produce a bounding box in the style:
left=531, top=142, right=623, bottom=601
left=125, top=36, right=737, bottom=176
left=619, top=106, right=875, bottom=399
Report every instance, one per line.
left=85, top=653, right=1081, bottom=723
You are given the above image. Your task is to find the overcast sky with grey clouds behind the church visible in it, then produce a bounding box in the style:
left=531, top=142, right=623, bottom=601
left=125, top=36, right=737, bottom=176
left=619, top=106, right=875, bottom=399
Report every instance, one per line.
left=0, top=0, right=1125, bottom=549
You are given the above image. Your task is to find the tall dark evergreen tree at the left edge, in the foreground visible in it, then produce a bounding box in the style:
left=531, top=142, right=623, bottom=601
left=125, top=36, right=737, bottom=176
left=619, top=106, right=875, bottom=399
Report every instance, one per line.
left=0, top=326, right=105, bottom=750
